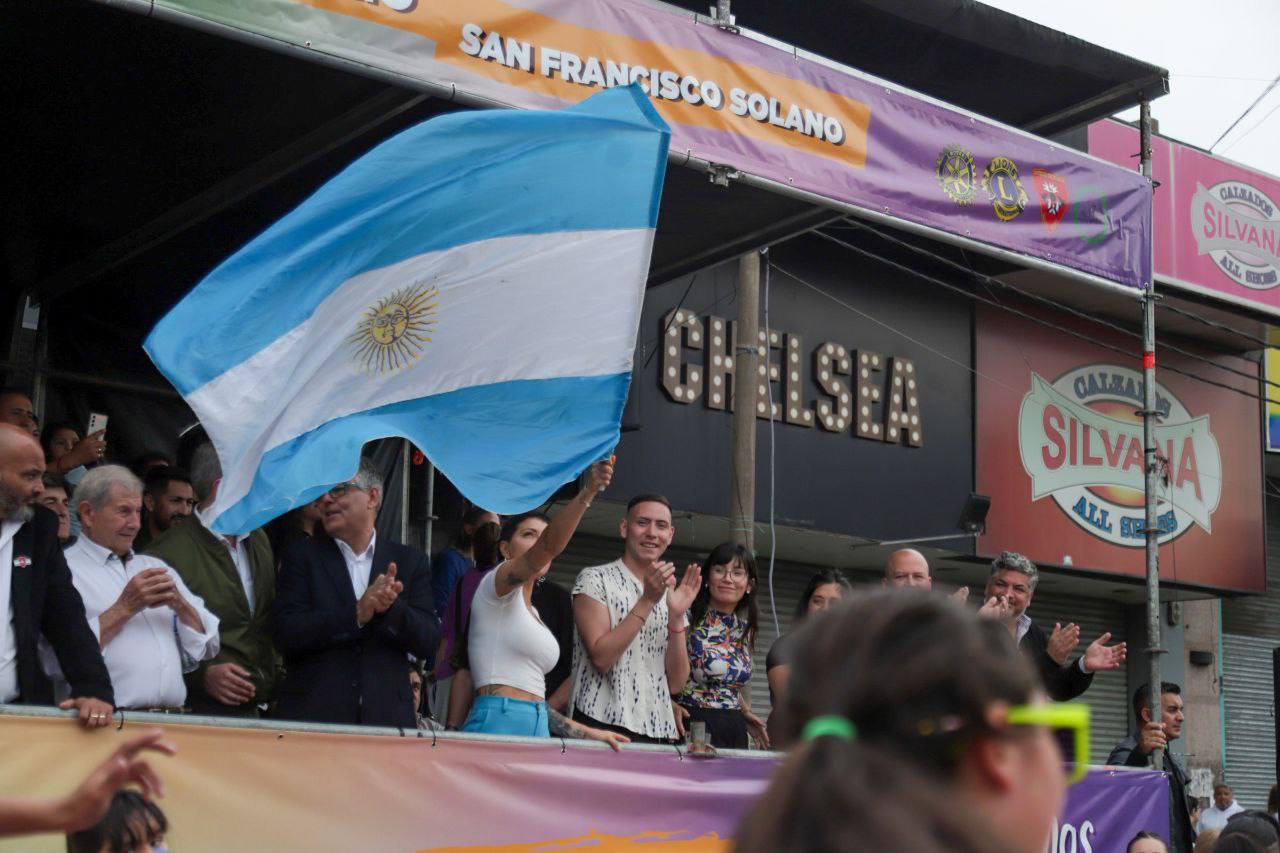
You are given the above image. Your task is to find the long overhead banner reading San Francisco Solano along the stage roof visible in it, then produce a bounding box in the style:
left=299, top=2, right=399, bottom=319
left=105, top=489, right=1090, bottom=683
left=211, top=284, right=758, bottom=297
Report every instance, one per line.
left=156, top=0, right=1152, bottom=287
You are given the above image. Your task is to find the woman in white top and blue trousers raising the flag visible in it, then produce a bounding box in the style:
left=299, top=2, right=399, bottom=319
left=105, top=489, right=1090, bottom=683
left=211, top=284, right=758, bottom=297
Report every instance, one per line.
left=462, top=459, right=627, bottom=749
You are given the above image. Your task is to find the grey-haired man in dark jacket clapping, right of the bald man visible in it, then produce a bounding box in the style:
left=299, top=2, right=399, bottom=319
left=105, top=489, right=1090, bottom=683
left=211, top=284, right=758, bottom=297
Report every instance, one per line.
left=983, top=551, right=1125, bottom=702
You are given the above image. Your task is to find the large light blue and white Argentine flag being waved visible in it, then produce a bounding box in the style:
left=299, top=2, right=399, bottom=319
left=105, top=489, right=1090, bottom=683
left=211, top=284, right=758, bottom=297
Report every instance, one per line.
left=145, top=86, right=669, bottom=534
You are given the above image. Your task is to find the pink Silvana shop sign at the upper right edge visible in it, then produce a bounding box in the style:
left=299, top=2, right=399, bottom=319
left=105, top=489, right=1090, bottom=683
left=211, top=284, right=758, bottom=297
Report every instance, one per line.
left=1089, top=120, right=1280, bottom=316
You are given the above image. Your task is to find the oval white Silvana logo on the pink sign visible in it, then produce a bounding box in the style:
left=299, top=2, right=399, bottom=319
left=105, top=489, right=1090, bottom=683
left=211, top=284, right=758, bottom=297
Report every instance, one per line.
left=1190, top=181, right=1280, bottom=291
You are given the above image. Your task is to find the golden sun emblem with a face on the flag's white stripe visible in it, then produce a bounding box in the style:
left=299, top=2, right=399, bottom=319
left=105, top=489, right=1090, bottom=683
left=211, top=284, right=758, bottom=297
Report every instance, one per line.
left=347, top=283, right=440, bottom=373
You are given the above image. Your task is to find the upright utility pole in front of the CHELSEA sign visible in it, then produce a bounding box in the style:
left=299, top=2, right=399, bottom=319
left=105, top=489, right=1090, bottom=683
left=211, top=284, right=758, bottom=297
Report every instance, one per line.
left=730, top=250, right=760, bottom=552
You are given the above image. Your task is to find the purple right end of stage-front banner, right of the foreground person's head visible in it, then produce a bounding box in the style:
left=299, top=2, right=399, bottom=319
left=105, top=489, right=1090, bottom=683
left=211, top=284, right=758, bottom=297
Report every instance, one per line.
left=1048, top=770, right=1169, bottom=853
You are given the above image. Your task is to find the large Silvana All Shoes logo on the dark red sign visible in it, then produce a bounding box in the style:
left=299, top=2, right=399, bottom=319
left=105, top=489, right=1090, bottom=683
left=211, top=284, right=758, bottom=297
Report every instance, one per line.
left=1018, top=365, right=1222, bottom=548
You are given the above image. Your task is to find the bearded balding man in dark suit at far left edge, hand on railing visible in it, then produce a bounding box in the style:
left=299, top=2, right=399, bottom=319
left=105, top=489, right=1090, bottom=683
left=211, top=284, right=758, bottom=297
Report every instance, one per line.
left=0, top=424, right=115, bottom=729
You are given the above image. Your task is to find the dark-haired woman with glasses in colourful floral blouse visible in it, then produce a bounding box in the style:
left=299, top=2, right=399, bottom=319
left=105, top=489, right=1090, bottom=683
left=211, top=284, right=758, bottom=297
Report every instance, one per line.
left=673, top=542, right=769, bottom=749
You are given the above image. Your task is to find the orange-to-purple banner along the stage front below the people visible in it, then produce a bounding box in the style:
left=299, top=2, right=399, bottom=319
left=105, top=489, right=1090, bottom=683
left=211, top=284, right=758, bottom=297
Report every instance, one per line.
left=0, top=716, right=1167, bottom=853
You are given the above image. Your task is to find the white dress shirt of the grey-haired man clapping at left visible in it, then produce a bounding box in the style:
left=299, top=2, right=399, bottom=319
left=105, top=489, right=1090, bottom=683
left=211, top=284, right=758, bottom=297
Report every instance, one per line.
left=55, top=537, right=219, bottom=708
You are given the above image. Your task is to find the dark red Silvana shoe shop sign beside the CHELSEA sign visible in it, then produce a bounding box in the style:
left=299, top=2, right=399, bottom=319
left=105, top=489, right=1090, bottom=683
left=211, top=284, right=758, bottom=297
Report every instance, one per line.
left=974, top=303, right=1266, bottom=592
